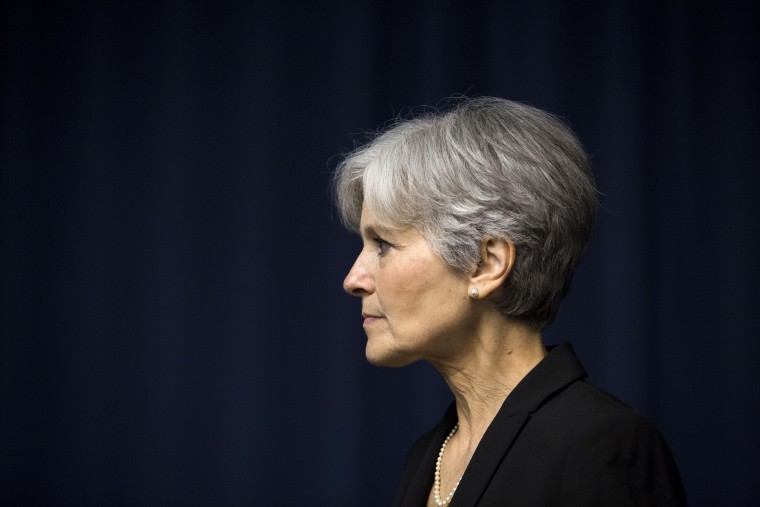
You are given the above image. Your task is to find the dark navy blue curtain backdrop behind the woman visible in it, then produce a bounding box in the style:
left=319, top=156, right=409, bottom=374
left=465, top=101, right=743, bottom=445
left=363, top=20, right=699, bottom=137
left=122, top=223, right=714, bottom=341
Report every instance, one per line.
left=0, top=0, right=760, bottom=506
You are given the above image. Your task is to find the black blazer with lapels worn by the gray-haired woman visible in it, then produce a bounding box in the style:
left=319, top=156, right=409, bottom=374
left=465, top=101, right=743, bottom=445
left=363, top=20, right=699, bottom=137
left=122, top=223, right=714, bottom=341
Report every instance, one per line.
left=393, top=343, right=686, bottom=507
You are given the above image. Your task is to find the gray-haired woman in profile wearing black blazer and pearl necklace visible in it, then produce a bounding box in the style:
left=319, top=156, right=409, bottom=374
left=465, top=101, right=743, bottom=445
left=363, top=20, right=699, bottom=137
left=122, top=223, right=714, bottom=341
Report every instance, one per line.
left=335, top=98, right=685, bottom=507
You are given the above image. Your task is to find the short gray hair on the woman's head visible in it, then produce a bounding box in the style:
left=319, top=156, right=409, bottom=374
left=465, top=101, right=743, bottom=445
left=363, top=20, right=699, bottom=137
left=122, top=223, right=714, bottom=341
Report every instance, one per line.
left=333, top=97, right=597, bottom=327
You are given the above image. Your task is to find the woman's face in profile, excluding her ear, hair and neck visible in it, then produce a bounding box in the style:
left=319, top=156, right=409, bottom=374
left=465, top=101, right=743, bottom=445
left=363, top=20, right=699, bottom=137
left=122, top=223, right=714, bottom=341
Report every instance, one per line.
left=343, top=207, right=473, bottom=366
